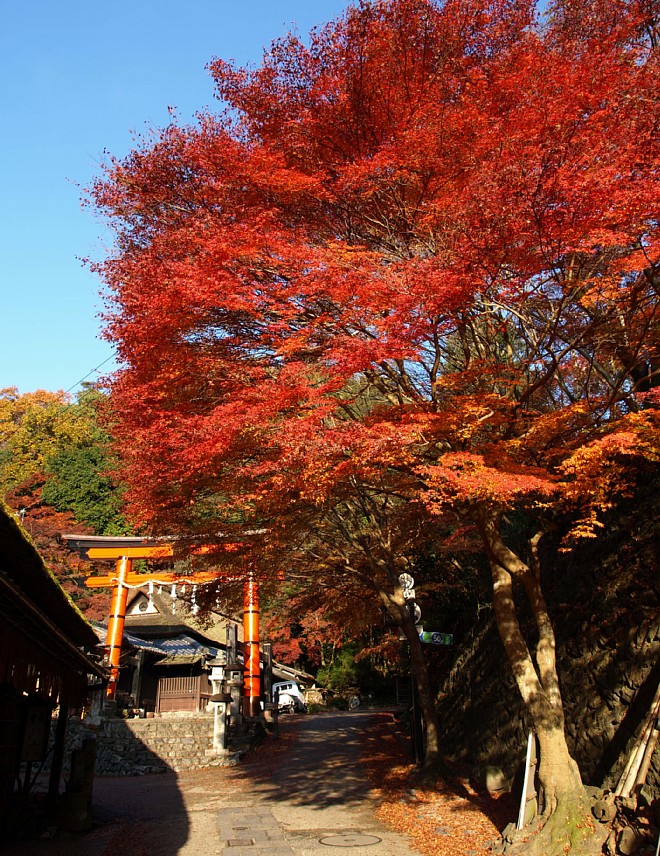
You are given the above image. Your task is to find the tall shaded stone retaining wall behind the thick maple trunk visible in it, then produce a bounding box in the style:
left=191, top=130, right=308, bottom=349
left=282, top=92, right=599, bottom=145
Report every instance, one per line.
left=438, top=498, right=660, bottom=796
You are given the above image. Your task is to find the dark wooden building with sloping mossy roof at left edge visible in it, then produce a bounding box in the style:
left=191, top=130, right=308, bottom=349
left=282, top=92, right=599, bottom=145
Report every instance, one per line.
left=0, top=504, right=107, bottom=826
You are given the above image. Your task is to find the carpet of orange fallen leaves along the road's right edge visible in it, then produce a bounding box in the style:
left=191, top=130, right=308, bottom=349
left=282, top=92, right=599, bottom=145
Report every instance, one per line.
left=362, top=714, right=515, bottom=856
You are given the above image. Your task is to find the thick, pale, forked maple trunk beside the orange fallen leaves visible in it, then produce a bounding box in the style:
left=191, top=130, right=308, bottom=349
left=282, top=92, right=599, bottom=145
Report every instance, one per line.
left=476, top=508, right=584, bottom=817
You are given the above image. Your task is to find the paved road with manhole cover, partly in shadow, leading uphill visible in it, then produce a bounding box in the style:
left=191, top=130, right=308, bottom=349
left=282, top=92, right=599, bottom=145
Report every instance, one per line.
left=0, top=712, right=417, bottom=856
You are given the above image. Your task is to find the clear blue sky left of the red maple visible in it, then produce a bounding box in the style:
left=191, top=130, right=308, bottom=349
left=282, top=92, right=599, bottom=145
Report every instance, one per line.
left=0, top=0, right=348, bottom=393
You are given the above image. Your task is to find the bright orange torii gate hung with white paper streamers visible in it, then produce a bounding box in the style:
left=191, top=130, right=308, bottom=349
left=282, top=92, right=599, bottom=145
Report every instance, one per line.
left=62, top=535, right=261, bottom=716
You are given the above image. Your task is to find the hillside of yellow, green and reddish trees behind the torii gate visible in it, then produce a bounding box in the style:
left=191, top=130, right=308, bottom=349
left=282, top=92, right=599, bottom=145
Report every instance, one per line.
left=0, top=387, right=129, bottom=619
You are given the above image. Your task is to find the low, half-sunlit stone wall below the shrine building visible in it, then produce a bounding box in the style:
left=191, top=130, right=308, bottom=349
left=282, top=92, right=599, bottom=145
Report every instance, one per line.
left=54, top=714, right=244, bottom=776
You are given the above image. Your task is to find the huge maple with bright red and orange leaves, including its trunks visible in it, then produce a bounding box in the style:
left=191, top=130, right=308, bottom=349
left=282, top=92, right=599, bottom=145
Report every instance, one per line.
left=91, top=0, right=660, bottom=847
